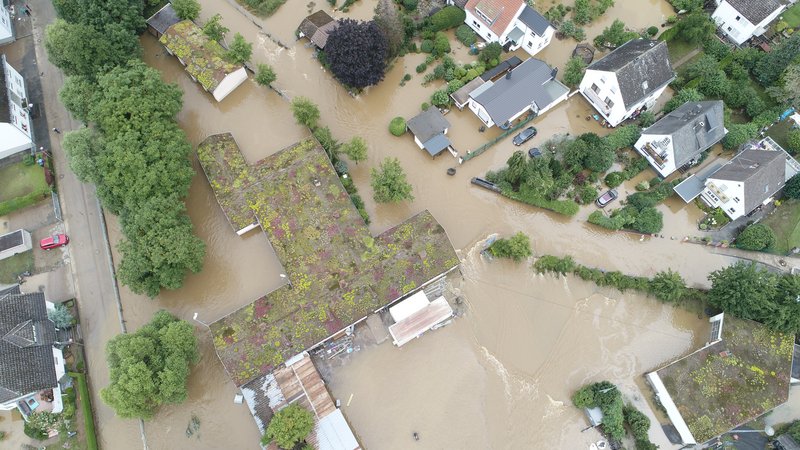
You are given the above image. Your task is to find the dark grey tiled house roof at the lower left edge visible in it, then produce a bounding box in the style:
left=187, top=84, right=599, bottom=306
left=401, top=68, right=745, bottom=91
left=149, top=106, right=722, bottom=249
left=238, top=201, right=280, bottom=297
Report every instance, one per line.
left=0, top=291, right=58, bottom=402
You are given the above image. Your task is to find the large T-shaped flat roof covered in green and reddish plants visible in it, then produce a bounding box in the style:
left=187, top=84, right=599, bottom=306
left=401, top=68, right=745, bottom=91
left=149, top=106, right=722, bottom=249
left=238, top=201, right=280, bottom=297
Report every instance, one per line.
left=198, top=134, right=458, bottom=385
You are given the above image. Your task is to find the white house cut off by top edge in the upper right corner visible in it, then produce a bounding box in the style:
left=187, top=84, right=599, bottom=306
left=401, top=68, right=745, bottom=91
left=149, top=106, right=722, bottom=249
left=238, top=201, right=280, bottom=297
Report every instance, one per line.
left=711, top=0, right=787, bottom=45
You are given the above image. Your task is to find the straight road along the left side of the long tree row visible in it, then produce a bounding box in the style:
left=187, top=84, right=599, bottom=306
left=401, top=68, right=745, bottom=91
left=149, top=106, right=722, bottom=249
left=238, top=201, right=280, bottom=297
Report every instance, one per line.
left=29, top=0, right=142, bottom=448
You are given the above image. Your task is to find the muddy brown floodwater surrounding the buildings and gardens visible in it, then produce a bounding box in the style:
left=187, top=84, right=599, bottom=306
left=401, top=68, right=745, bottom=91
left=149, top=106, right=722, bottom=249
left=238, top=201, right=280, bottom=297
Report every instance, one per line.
left=86, top=0, right=744, bottom=449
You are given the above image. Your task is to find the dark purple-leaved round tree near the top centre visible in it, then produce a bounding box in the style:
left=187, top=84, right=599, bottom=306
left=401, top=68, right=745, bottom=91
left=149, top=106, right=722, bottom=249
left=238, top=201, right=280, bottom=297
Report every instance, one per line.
left=325, top=19, right=389, bottom=89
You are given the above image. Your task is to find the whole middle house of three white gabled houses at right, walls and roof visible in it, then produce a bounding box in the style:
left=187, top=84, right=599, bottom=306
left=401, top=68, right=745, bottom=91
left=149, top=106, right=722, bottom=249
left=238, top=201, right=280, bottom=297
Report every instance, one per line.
left=634, top=100, right=726, bottom=177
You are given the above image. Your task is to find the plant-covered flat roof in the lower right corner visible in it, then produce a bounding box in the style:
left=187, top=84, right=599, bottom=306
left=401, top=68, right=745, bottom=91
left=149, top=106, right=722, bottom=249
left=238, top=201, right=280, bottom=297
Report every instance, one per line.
left=658, top=314, right=794, bottom=442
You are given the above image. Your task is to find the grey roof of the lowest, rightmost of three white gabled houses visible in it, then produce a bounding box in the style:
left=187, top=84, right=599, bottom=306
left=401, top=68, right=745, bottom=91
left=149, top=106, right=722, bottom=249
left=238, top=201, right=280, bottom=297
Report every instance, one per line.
left=712, top=149, right=786, bottom=213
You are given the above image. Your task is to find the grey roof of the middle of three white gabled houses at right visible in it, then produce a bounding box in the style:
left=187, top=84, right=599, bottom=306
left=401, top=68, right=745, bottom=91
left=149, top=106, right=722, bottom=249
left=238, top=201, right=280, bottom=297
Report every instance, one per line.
left=642, top=100, right=725, bottom=168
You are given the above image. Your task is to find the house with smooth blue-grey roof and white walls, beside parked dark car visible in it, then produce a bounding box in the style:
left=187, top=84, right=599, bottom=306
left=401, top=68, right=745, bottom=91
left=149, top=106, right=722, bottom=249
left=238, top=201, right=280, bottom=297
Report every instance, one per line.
left=469, top=58, right=569, bottom=128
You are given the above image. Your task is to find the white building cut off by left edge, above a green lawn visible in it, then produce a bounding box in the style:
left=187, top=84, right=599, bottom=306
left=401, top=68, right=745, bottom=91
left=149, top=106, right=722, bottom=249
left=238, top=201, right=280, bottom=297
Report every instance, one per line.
left=0, top=55, right=33, bottom=159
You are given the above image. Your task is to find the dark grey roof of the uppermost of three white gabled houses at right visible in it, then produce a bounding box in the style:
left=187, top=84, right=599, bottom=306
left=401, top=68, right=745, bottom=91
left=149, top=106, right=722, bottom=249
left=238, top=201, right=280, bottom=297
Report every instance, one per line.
left=587, top=39, right=675, bottom=109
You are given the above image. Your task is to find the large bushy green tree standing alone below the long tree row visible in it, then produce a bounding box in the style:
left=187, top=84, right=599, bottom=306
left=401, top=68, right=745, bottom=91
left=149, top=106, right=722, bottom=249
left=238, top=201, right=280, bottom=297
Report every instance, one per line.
left=100, top=310, right=200, bottom=419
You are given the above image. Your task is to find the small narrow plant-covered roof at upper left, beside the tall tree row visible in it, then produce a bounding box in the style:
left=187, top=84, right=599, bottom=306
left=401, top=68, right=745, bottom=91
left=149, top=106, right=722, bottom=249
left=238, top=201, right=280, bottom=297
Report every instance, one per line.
left=160, top=20, right=242, bottom=92
